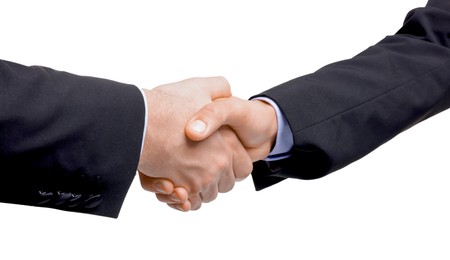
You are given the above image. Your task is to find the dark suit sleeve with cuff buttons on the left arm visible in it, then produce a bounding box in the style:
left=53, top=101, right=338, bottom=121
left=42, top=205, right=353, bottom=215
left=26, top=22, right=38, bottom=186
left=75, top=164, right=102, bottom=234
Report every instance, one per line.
left=0, top=61, right=145, bottom=217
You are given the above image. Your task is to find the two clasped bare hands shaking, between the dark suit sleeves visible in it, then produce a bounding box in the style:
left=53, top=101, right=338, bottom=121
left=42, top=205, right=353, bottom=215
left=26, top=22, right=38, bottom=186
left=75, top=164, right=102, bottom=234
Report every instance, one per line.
left=138, top=77, right=277, bottom=211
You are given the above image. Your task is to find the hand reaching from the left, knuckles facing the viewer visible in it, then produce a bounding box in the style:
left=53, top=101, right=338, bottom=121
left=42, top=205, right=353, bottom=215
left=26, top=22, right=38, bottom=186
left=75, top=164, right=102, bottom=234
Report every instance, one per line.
left=138, top=77, right=253, bottom=210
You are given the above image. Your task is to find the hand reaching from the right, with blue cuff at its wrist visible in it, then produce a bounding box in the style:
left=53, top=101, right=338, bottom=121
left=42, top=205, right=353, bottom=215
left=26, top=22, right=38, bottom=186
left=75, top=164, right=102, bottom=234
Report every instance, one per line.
left=148, top=97, right=278, bottom=210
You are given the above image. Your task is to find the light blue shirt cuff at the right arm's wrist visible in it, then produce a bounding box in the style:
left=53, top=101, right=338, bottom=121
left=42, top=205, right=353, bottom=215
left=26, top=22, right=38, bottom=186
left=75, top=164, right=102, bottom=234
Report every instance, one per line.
left=254, top=97, right=294, bottom=161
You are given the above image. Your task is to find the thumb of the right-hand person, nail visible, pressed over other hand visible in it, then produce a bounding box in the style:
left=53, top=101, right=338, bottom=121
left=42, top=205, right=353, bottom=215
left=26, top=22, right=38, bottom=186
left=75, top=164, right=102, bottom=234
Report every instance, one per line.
left=185, top=97, right=246, bottom=141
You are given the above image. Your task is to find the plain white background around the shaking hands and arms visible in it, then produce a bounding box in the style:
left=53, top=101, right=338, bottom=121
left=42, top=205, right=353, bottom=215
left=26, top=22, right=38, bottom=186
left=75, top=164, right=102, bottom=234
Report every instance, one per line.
left=0, top=0, right=450, bottom=260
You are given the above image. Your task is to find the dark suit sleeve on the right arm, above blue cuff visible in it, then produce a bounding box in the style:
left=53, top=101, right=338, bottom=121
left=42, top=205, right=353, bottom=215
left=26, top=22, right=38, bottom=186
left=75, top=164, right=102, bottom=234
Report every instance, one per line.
left=252, top=0, right=450, bottom=190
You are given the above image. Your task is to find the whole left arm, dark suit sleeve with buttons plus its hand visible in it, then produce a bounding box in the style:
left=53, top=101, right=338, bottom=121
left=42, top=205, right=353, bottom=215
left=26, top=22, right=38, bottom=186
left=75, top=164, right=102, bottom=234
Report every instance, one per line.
left=0, top=61, right=252, bottom=217
